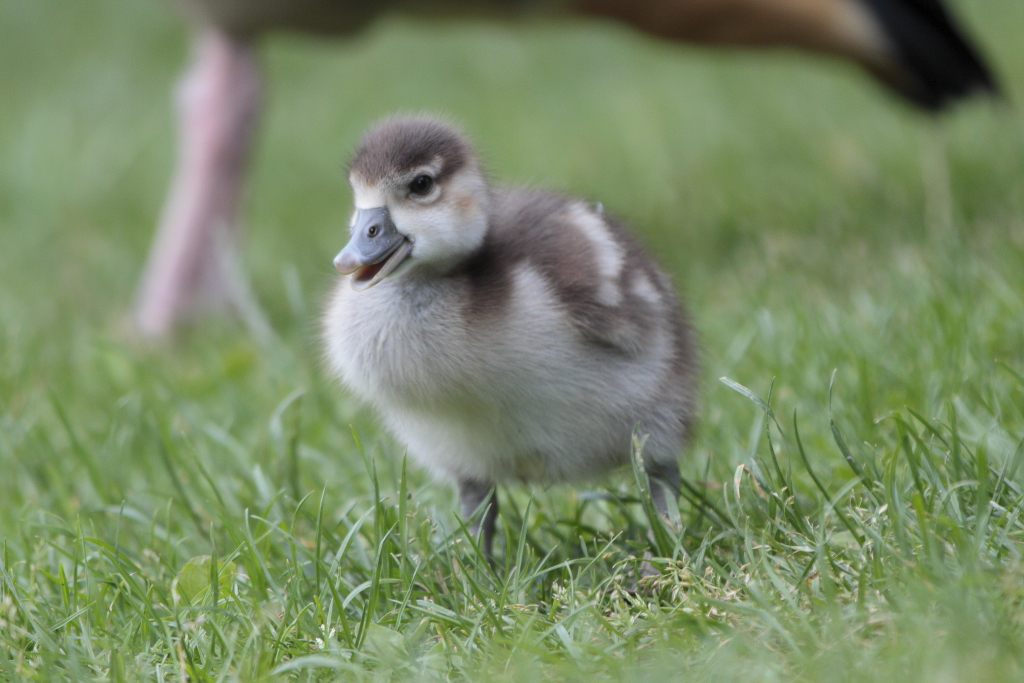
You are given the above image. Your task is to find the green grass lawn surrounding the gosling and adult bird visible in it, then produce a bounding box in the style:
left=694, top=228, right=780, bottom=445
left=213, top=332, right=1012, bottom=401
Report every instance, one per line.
left=0, top=0, right=1024, bottom=683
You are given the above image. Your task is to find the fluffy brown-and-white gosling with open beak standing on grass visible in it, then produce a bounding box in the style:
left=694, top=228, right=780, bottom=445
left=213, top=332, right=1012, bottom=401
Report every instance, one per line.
left=324, top=117, right=695, bottom=557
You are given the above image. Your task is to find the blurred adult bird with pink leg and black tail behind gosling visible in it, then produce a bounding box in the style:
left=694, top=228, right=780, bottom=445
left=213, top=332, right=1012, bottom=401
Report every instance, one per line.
left=133, top=0, right=995, bottom=337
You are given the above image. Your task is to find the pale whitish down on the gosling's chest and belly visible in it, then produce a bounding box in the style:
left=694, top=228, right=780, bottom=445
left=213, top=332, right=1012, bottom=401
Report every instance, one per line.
left=325, top=261, right=674, bottom=482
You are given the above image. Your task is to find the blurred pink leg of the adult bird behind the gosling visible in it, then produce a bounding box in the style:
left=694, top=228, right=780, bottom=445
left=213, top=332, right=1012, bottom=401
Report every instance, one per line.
left=133, top=29, right=260, bottom=338
